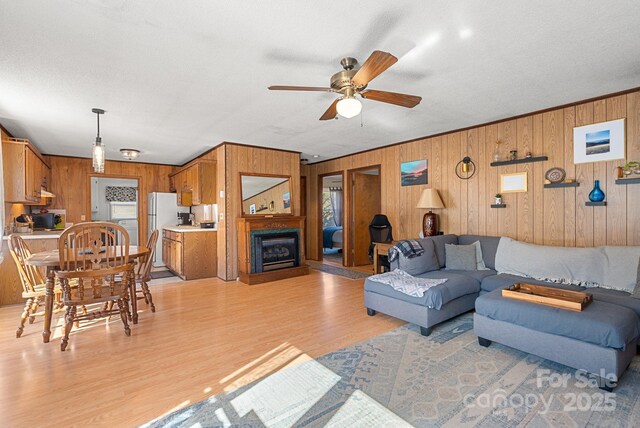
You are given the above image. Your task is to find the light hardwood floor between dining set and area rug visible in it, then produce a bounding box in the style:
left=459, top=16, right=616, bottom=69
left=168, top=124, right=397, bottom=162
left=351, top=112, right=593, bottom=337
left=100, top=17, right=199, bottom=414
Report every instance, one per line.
left=0, top=270, right=403, bottom=427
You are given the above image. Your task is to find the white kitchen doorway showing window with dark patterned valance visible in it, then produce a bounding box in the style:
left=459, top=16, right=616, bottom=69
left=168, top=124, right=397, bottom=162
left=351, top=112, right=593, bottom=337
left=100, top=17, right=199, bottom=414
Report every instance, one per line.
left=89, top=176, right=140, bottom=245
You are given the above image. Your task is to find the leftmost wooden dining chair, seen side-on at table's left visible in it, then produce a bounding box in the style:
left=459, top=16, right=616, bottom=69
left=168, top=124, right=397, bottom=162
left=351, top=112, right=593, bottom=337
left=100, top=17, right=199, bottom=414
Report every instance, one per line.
left=9, top=235, right=62, bottom=338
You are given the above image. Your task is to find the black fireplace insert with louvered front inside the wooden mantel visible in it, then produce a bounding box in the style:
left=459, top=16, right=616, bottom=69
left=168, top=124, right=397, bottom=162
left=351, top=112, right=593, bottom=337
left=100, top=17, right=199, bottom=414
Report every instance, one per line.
left=253, top=232, right=300, bottom=273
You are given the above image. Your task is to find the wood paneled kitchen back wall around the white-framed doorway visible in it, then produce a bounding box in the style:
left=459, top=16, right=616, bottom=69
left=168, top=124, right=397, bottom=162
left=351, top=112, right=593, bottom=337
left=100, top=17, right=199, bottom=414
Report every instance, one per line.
left=46, top=156, right=177, bottom=243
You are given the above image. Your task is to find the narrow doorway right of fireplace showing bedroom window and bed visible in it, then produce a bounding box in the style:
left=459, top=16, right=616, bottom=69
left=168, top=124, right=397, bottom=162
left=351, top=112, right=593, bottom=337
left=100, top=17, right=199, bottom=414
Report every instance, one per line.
left=318, top=172, right=344, bottom=266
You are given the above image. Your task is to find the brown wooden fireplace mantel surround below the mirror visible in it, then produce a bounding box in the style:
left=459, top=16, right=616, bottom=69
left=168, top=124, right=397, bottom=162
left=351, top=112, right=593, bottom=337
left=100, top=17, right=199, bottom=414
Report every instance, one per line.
left=238, top=216, right=309, bottom=284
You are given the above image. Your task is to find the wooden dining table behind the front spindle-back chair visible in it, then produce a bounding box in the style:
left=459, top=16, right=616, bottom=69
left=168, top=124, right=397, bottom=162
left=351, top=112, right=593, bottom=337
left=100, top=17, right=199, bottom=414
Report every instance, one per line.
left=25, top=245, right=149, bottom=343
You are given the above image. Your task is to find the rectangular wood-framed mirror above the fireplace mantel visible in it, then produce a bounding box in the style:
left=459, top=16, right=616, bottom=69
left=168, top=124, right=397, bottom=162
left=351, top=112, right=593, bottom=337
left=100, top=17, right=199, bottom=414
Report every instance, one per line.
left=240, top=173, right=293, bottom=216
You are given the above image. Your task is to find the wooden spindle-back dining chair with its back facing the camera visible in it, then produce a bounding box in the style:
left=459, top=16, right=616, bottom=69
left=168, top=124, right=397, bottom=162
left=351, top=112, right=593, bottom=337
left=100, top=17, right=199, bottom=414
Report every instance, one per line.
left=56, top=222, right=135, bottom=351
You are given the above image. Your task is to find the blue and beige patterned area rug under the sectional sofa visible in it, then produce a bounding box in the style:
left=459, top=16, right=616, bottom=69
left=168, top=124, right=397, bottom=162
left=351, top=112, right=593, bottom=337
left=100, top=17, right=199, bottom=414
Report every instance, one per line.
left=146, top=314, right=640, bottom=427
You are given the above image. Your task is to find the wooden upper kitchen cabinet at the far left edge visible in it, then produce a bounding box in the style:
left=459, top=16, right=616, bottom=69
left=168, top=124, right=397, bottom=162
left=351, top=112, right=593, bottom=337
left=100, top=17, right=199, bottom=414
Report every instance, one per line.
left=2, top=138, right=51, bottom=205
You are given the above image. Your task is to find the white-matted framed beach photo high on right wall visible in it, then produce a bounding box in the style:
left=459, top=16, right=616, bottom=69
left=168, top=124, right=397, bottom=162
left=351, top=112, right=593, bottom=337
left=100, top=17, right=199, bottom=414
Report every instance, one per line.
left=573, top=119, right=625, bottom=163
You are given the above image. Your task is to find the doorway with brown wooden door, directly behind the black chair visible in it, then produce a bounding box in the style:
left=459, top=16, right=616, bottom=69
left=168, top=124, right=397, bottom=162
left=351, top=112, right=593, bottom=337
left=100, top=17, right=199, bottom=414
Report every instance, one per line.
left=347, top=165, right=382, bottom=269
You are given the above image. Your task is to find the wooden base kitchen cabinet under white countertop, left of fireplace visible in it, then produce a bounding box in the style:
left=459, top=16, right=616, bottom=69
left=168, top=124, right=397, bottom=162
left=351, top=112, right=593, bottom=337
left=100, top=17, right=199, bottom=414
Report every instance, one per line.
left=162, top=228, right=218, bottom=280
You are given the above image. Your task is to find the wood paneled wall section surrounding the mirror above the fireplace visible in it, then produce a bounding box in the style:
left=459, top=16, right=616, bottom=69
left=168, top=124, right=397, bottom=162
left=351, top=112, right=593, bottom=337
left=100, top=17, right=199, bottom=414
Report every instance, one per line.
left=194, top=143, right=300, bottom=281
